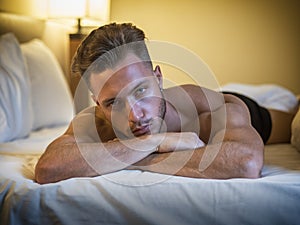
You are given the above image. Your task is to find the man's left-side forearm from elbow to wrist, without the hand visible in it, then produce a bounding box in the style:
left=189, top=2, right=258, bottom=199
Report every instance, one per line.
left=35, top=136, right=159, bottom=183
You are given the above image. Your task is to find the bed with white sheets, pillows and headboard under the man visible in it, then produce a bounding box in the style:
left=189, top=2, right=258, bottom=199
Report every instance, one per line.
left=0, top=13, right=300, bottom=225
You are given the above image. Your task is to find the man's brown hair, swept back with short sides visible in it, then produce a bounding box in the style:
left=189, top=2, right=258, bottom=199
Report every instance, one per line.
left=71, top=23, right=152, bottom=87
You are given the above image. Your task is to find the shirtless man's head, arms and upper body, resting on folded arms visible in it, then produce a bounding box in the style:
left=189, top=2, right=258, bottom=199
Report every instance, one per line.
left=35, top=23, right=290, bottom=183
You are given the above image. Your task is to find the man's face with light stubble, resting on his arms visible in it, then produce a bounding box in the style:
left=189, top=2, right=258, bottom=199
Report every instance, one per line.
left=91, top=55, right=166, bottom=138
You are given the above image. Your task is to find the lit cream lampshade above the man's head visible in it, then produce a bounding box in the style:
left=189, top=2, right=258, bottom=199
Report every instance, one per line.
left=48, top=0, right=110, bottom=33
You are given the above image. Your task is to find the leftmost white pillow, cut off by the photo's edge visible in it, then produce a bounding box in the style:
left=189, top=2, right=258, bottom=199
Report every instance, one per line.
left=0, top=33, right=32, bottom=142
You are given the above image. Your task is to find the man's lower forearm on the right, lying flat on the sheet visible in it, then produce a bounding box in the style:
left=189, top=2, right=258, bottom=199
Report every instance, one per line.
left=128, top=142, right=261, bottom=179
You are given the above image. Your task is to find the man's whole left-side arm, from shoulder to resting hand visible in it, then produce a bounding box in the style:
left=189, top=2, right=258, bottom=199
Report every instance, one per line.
left=35, top=108, right=203, bottom=183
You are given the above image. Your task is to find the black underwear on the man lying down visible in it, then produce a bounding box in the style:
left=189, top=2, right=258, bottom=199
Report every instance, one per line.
left=222, top=91, right=272, bottom=143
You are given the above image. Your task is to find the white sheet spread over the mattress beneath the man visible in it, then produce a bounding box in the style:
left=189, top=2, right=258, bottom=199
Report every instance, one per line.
left=0, top=127, right=300, bottom=225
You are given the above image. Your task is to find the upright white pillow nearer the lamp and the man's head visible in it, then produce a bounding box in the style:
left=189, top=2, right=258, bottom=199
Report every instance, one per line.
left=21, top=39, right=74, bottom=130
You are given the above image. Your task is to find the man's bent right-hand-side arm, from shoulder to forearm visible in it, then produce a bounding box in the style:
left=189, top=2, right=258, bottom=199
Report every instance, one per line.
left=130, top=96, right=263, bottom=179
